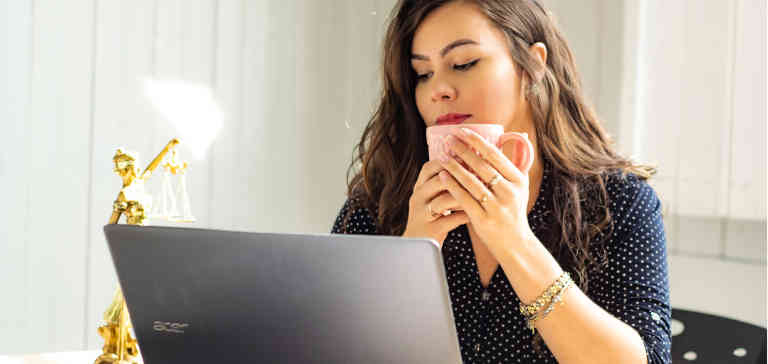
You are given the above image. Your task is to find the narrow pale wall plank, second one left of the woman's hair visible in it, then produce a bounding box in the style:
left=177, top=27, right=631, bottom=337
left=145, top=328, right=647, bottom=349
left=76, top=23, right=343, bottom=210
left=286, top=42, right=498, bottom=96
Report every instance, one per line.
left=239, top=1, right=300, bottom=232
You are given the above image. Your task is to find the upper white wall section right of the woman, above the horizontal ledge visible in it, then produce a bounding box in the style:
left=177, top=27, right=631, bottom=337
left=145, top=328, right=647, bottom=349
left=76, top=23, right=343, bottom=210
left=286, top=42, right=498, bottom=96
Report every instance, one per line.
left=545, top=0, right=766, bottom=228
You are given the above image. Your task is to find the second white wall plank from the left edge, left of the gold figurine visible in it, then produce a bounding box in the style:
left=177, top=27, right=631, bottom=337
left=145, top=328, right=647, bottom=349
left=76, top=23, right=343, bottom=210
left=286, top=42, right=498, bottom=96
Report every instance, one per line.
left=24, top=0, right=94, bottom=350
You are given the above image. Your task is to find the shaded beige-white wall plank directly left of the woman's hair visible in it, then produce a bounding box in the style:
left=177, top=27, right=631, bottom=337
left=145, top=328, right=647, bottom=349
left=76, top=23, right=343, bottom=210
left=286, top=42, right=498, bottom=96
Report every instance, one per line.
left=296, top=1, right=393, bottom=232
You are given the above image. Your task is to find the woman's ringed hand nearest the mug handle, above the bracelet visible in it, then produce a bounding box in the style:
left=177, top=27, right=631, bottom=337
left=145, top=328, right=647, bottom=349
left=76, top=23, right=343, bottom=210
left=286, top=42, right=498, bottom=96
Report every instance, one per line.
left=439, top=128, right=533, bottom=255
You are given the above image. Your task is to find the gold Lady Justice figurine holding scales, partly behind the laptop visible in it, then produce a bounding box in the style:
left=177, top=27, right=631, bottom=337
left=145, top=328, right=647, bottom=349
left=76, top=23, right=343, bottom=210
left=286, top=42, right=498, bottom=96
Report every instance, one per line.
left=94, top=139, right=188, bottom=364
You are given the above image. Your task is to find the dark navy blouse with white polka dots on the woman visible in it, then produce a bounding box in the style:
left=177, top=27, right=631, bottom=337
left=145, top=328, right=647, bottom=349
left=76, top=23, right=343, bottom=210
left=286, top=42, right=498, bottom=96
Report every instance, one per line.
left=331, top=163, right=671, bottom=364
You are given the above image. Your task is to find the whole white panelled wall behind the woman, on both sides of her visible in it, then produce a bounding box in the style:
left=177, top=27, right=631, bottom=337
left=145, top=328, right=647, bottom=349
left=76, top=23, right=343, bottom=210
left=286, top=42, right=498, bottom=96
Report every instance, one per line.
left=0, top=0, right=766, bottom=353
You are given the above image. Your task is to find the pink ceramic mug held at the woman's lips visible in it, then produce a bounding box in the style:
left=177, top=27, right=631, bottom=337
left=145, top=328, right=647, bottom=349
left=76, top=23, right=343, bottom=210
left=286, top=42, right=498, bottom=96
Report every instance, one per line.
left=427, top=124, right=533, bottom=173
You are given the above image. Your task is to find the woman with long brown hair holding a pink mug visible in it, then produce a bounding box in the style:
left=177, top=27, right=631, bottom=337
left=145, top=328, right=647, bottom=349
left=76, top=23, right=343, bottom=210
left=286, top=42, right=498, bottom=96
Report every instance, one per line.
left=332, top=0, right=671, bottom=363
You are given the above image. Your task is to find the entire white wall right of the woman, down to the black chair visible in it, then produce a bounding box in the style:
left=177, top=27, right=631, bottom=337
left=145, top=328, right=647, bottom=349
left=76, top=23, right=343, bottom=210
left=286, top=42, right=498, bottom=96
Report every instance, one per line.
left=547, top=0, right=766, bottom=326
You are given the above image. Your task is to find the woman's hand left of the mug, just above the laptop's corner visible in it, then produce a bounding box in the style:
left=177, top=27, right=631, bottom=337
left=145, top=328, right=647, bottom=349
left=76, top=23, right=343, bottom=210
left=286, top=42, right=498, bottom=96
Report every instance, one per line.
left=403, top=161, right=469, bottom=247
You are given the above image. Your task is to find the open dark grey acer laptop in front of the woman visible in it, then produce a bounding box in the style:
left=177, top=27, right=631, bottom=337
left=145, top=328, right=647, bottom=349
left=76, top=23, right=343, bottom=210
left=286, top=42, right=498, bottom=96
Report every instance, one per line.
left=104, top=225, right=461, bottom=364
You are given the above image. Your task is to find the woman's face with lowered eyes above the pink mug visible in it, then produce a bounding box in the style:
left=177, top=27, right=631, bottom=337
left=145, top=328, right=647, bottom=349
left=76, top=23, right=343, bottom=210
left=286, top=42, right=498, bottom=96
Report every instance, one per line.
left=411, top=2, right=535, bottom=135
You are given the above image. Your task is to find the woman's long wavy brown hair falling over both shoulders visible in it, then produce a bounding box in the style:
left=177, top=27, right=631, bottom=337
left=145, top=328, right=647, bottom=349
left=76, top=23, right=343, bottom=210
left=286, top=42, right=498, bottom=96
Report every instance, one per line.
left=342, top=0, right=655, bottom=351
